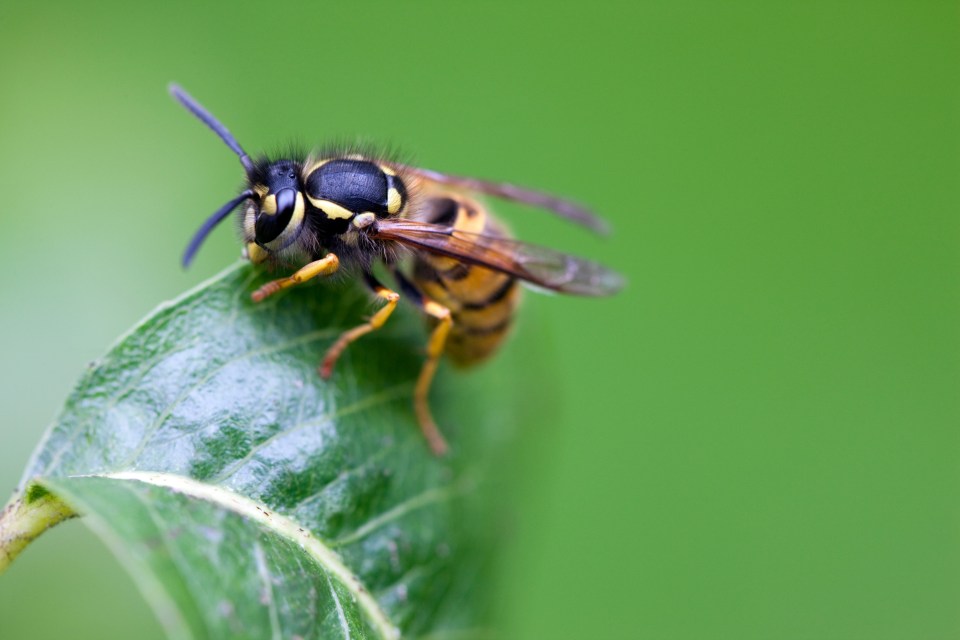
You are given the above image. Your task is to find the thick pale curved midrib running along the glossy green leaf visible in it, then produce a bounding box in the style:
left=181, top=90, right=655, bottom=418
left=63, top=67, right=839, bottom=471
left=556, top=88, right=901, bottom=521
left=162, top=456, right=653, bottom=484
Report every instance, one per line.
left=82, top=471, right=400, bottom=640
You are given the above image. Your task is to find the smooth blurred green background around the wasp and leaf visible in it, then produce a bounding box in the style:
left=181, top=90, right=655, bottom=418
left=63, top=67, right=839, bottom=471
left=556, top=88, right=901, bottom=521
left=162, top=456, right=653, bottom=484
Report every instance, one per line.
left=0, top=1, right=960, bottom=640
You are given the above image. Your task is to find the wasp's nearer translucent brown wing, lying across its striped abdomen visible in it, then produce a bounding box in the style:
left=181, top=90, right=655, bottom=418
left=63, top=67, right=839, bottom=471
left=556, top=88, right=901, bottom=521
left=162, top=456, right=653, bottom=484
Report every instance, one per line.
left=371, top=218, right=623, bottom=296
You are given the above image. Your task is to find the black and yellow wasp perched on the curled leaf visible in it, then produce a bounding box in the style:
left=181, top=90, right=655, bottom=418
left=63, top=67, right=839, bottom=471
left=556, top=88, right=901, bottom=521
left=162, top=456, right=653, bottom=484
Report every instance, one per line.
left=170, top=85, right=623, bottom=455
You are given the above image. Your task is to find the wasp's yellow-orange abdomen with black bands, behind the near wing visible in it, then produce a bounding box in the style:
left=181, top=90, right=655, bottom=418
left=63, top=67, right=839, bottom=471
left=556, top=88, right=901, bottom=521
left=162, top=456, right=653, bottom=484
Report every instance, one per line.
left=413, top=197, right=520, bottom=366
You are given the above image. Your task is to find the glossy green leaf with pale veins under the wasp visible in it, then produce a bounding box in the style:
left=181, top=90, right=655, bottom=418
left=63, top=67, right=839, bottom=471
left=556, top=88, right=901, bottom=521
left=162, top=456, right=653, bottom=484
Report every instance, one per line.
left=0, top=266, right=506, bottom=638
